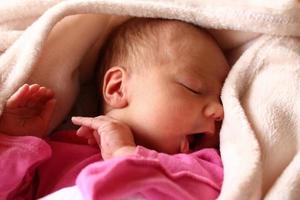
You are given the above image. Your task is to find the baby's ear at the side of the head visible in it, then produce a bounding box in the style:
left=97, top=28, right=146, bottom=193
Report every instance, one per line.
left=102, top=66, right=128, bottom=108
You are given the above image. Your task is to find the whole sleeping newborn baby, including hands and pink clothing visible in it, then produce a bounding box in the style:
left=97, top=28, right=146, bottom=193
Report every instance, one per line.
left=0, top=18, right=229, bottom=199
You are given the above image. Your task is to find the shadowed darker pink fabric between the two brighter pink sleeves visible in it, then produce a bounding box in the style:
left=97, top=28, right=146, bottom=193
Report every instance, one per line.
left=37, top=131, right=101, bottom=197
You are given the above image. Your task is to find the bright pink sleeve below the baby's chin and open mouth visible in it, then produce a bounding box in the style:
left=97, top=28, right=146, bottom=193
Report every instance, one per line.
left=77, top=147, right=223, bottom=200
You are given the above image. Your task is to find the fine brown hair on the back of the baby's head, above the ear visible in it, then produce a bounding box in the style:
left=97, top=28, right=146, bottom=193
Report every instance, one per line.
left=98, top=18, right=175, bottom=80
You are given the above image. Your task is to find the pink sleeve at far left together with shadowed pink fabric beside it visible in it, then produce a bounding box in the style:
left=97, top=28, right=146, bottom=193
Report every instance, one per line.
left=0, top=131, right=101, bottom=200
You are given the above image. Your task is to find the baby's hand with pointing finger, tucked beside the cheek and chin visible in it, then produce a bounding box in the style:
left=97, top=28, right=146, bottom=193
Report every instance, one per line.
left=72, top=115, right=136, bottom=160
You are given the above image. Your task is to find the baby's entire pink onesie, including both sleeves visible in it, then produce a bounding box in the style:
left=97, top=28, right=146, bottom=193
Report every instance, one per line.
left=0, top=131, right=223, bottom=200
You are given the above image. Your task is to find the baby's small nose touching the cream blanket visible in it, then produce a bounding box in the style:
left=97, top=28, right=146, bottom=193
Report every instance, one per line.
left=204, top=102, right=224, bottom=121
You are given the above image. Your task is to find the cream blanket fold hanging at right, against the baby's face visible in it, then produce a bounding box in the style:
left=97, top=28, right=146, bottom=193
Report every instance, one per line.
left=221, top=36, right=300, bottom=199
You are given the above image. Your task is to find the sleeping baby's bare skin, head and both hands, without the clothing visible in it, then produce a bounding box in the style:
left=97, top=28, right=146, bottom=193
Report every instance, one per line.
left=0, top=18, right=229, bottom=159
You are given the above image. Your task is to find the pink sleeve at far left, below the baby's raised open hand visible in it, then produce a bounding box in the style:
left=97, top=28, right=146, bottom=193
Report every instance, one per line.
left=0, top=134, right=51, bottom=200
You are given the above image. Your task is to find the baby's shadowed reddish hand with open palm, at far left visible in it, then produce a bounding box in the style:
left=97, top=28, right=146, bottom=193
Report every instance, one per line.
left=0, top=84, right=56, bottom=137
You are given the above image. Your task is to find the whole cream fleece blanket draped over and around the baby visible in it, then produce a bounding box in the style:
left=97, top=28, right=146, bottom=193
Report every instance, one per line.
left=0, top=0, right=300, bottom=200
